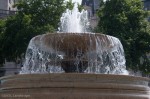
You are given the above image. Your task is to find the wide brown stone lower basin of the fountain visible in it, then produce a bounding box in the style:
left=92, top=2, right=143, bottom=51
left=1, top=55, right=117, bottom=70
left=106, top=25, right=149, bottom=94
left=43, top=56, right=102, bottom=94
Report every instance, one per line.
left=0, top=73, right=150, bottom=99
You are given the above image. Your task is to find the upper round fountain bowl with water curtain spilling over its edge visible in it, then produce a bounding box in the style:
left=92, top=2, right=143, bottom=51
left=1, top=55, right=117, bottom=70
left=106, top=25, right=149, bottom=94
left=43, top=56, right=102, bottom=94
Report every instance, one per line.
left=21, top=33, right=126, bottom=74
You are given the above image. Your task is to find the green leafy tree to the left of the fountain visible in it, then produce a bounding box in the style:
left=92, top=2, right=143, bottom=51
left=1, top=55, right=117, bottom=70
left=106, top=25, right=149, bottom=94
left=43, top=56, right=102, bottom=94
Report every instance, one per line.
left=0, top=0, right=66, bottom=61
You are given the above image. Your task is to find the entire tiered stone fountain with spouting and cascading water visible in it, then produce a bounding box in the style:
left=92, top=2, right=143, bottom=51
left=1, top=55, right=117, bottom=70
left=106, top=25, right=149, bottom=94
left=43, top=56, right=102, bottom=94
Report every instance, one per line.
left=0, top=2, right=150, bottom=99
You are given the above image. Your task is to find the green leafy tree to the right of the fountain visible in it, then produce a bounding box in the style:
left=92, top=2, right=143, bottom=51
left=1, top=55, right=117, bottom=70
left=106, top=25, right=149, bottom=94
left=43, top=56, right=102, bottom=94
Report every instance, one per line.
left=96, top=0, right=150, bottom=73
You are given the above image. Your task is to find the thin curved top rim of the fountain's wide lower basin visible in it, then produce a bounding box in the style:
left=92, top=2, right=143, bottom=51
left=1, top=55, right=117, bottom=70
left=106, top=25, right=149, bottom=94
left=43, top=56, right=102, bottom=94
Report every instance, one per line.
left=0, top=73, right=150, bottom=82
